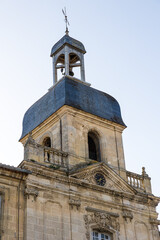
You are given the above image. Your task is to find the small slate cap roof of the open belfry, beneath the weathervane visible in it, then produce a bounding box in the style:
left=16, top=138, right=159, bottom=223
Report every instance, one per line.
left=50, top=35, right=86, bottom=57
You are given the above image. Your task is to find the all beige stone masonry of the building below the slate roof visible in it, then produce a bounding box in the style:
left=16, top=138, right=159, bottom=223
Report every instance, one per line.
left=0, top=102, right=159, bottom=240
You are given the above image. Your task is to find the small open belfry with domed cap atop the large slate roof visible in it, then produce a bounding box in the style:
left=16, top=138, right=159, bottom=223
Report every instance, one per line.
left=50, top=32, right=86, bottom=85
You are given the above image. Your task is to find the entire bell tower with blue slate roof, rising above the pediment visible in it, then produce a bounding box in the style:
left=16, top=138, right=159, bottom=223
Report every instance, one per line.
left=20, top=30, right=126, bottom=178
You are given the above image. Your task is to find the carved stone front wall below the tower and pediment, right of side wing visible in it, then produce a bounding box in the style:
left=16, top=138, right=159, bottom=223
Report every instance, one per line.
left=18, top=162, right=159, bottom=240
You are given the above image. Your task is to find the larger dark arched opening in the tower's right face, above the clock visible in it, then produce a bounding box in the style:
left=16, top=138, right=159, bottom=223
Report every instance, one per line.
left=88, top=132, right=100, bottom=162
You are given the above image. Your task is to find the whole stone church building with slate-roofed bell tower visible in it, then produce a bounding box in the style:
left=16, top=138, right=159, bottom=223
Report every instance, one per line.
left=0, top=34, right=160, bottom=240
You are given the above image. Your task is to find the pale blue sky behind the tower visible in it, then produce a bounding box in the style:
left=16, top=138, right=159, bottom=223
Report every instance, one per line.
left=0, top=0, right=160, bottom=217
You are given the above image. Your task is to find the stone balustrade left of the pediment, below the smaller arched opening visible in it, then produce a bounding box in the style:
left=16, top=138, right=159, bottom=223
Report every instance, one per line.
left=44, top=147, right=68, bottom=167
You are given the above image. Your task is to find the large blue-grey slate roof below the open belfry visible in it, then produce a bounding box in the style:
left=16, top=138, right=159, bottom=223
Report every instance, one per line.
left=20, top=77, right=125, bottom=139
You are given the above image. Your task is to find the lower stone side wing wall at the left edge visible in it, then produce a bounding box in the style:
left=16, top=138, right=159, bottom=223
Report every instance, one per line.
left=0, top=166, right=27, bottom=240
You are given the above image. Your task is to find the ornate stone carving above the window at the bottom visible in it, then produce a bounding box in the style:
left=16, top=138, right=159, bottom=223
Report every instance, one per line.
left=84, top=211, right=120, bottom=240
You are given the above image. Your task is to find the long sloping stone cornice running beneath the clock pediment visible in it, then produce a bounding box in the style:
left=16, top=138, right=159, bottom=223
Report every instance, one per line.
left=18, top=160, right=160, bottom=206
